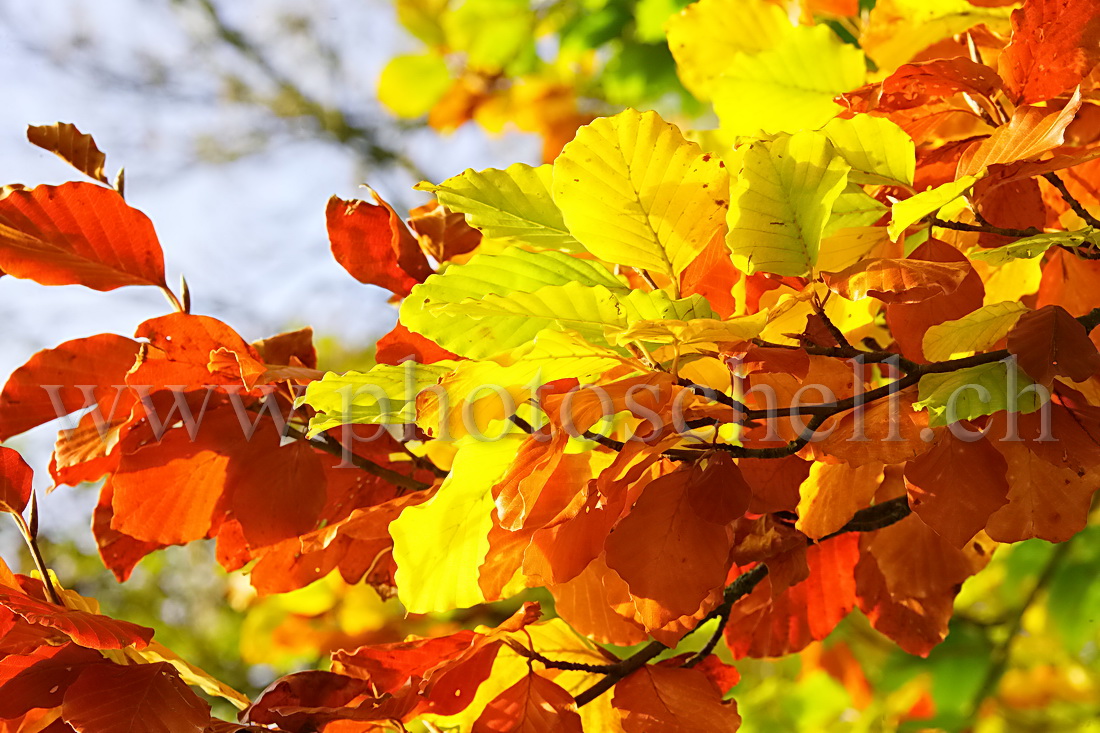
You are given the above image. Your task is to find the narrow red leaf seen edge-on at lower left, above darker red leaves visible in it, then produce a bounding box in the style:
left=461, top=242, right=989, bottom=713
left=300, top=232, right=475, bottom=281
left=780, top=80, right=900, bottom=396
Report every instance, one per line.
left=0, top=588, right=153, bottom=649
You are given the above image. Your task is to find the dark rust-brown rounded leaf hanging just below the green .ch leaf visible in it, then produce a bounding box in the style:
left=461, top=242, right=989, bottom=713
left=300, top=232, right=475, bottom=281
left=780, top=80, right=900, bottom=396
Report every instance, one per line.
left=905, top=430, right=1009, bottom=547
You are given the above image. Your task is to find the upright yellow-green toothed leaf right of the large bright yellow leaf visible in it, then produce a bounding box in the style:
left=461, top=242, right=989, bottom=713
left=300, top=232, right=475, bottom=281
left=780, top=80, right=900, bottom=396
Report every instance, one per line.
left=726, top=132, right=848, bottom=276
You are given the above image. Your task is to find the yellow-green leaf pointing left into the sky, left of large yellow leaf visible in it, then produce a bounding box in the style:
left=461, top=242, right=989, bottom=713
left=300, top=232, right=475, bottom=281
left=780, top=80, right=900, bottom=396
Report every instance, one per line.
left=416, top=163, right=584, bottom=252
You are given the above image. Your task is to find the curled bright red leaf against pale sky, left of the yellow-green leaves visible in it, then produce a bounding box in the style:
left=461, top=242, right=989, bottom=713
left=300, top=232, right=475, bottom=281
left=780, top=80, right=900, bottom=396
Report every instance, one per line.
left=325, top=194, right=431, bottom=296
